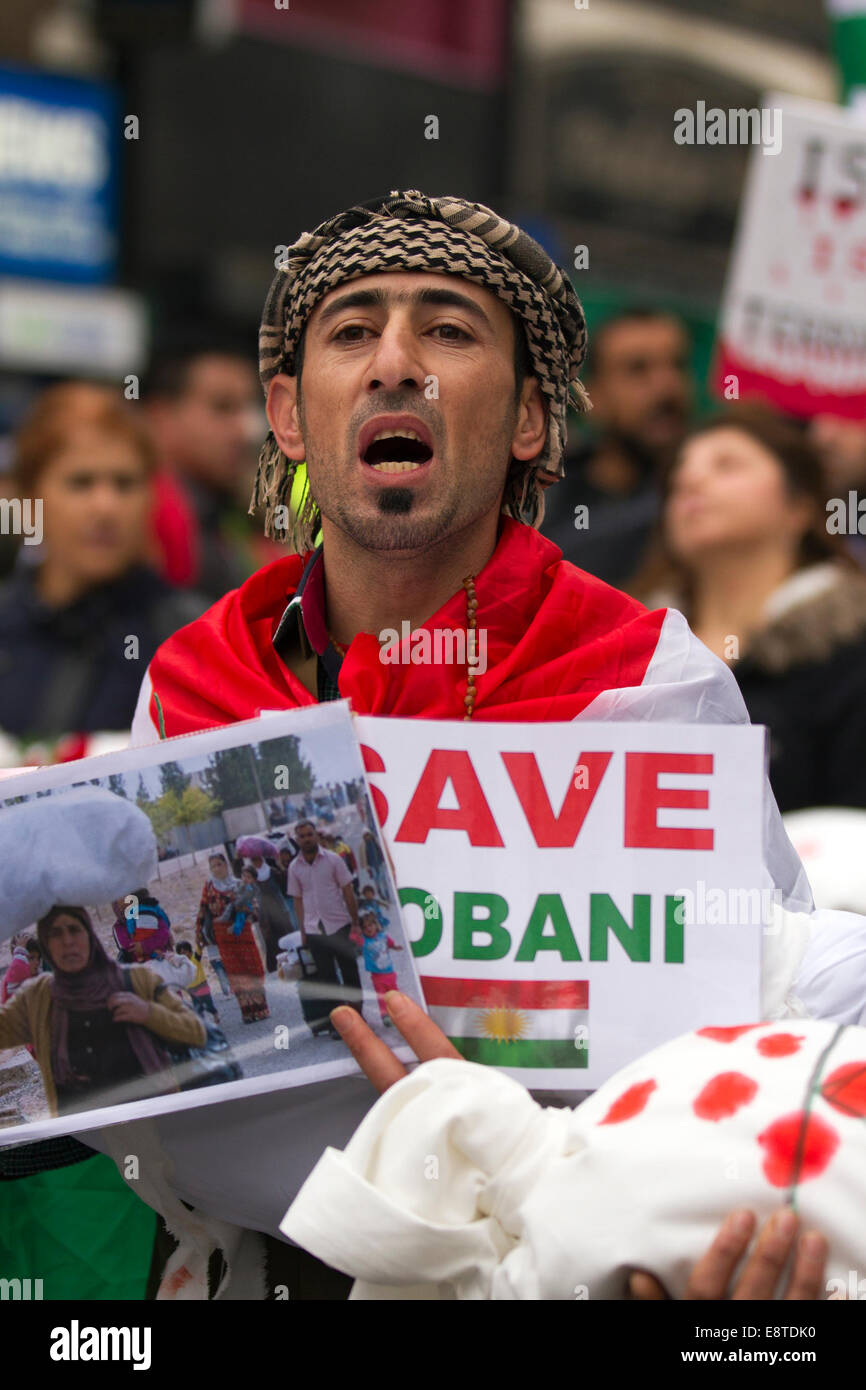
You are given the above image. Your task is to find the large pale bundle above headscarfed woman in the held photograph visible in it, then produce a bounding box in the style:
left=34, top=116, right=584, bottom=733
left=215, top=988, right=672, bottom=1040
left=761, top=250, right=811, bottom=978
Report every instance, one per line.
left=0, top=787, right=157, bottom=940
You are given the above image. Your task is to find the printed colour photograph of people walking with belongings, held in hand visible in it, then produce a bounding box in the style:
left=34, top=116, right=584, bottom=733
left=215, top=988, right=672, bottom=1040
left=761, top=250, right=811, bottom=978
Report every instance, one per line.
left=0, top=702, right=421, bottom=1145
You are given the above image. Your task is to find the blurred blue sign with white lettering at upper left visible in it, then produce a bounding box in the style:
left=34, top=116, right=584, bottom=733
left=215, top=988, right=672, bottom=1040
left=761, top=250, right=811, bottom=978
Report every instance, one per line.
left=0, top=67, right=120, bottom=285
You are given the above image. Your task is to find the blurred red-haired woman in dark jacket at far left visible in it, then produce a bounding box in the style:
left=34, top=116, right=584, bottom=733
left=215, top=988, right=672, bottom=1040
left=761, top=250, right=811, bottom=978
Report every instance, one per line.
left=0, top=382, right=204, bottom=741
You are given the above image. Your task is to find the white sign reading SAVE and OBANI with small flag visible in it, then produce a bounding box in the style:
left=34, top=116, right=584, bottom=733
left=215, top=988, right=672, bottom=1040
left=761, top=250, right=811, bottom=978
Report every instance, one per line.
left=356, top=719, right=771, bottom=1090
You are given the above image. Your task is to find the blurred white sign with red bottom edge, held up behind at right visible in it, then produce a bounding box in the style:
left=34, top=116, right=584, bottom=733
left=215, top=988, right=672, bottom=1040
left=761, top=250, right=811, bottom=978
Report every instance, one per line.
left=714, top=95, right=866, bottom=420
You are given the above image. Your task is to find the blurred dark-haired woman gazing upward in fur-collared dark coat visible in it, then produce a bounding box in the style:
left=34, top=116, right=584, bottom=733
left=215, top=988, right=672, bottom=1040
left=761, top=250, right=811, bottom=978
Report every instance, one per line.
left=638, top=404, right=866, bottom=812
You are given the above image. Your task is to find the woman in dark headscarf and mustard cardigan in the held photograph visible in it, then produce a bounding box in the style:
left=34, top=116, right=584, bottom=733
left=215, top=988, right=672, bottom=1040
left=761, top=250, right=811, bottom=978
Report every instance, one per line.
left=0, top=905, right=206, bottom=1115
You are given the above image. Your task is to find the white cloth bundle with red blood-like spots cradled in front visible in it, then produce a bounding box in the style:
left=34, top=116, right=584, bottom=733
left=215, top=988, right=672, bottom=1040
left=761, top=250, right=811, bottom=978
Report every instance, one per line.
left=281, top=1019, right=866, bottom=1300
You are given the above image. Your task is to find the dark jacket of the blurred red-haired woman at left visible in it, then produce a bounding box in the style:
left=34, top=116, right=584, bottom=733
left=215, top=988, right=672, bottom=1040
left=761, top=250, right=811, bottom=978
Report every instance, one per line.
left=0, top=566, right=206, bottom=739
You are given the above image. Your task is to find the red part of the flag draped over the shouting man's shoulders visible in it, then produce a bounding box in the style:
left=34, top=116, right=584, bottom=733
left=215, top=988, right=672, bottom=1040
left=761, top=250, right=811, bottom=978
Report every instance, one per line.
left=136, top=517, right=666, bottom=737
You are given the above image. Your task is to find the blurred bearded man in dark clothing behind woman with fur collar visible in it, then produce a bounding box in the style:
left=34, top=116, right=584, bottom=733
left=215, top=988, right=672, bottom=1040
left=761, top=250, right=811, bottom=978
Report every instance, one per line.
left=541, top=309, right=692, bottom=588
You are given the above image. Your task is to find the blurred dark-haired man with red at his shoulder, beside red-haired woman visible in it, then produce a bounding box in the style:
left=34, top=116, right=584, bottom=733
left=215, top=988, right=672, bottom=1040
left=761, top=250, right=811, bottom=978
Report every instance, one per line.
left=143, top=336, right=274, bottom=599
